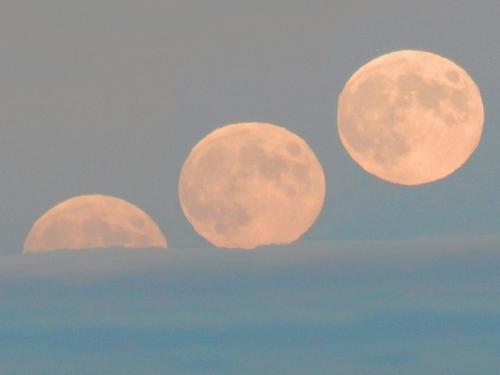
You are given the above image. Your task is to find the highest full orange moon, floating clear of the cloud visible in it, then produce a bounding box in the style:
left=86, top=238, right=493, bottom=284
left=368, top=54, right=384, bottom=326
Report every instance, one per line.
left=337, top=51, right=484, bottom=185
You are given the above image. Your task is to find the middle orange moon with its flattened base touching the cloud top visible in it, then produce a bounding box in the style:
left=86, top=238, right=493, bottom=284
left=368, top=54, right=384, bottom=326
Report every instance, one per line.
left=179, top=123, right=325, bottom=249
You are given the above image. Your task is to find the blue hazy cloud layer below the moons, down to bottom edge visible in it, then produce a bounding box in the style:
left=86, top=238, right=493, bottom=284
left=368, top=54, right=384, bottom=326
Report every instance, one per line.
left=0, top=236, right=500, bottom=375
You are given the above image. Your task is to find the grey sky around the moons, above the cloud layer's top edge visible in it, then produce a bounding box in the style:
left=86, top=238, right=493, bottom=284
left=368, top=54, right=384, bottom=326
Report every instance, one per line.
left=0, top=0, right=500, bottom=254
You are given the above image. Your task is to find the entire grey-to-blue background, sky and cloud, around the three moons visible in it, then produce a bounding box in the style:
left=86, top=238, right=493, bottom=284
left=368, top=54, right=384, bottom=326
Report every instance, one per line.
left=0, top=0, right=500, bottom=375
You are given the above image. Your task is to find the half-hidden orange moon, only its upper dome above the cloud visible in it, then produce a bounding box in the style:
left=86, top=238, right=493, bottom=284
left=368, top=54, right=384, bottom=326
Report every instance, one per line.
left=24, top=195, right=167, bottom=252
